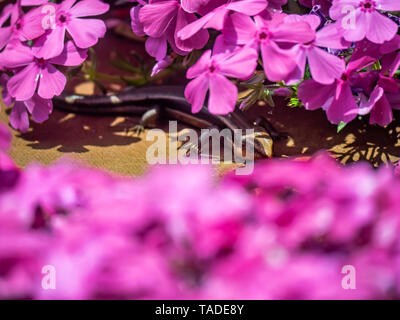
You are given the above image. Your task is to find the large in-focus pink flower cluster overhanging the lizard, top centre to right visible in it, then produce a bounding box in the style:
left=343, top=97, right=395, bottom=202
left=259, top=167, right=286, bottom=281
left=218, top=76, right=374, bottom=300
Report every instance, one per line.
left=131, top=0, right=400, bottom=126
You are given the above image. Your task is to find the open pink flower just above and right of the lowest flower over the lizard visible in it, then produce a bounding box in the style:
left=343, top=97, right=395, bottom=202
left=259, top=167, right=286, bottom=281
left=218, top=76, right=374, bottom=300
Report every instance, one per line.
left=223, top=13, right=315, bottom=81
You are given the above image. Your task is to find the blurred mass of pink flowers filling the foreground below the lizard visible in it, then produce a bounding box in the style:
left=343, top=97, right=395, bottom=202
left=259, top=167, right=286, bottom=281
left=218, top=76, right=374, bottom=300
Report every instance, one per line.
left=0, top=127, right=400, bottom=299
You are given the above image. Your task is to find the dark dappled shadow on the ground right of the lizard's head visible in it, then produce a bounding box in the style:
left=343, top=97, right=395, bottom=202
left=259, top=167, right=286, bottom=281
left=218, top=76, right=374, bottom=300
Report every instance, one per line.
left=252, top=100, right=400, bottom=166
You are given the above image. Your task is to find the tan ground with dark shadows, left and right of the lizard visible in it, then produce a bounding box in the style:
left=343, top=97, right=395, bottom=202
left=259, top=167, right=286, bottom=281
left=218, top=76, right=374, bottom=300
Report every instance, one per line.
left=1, top=99, right=400, bottom=175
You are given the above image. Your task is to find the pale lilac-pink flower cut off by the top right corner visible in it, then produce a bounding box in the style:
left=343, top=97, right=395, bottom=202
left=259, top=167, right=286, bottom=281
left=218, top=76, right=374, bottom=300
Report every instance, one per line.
left=329, top=0, right=400, bottom=43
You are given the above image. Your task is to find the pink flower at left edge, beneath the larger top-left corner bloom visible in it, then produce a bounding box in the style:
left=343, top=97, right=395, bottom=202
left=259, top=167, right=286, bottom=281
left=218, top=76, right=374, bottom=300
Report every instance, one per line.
left=0, top=41, right=87, bottom=101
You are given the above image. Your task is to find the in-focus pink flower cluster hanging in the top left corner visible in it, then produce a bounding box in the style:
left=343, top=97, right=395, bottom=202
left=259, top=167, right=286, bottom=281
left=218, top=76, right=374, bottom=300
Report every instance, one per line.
left=0, top=0, right=109, bottom=132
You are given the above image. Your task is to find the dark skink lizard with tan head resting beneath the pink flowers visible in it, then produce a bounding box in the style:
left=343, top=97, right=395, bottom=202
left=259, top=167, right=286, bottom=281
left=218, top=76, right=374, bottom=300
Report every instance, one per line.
left=53, top=86, right=273, bottom=158
